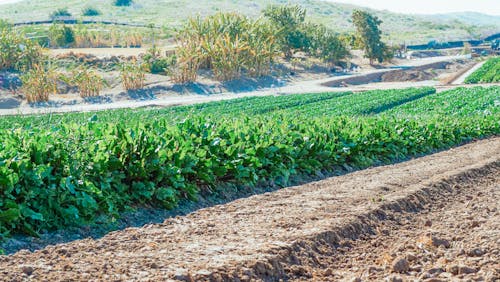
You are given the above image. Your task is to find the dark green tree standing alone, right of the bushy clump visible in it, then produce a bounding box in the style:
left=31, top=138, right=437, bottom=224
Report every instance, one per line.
left=352, top=10, right=392, bottom=64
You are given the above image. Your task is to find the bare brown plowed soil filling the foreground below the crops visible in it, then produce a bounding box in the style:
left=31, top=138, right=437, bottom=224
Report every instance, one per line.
left=0, top=137, right=500, bottom=281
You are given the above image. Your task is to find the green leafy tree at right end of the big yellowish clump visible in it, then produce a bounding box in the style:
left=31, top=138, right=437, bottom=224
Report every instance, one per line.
left=264, top=5, right=309, bottom=58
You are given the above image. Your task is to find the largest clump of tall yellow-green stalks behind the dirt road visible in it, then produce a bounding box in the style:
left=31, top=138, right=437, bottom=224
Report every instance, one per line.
left=172, top=13, right=280, bottom=83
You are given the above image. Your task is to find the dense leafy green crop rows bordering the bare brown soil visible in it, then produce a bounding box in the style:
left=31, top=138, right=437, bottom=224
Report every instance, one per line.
left=0, top=87, right=500, bottom=236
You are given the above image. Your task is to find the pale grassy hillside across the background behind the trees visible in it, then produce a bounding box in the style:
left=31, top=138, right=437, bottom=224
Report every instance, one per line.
left=0, top=0, right=500, bottom=44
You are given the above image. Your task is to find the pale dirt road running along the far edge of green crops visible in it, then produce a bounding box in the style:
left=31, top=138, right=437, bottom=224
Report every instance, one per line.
left=0, top=56, right=478, bottom=116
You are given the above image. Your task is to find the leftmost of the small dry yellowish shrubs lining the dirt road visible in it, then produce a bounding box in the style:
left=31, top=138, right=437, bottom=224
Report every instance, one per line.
left=21, top=64, right=59, bottom=103
